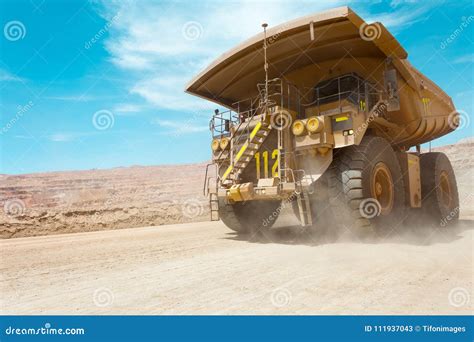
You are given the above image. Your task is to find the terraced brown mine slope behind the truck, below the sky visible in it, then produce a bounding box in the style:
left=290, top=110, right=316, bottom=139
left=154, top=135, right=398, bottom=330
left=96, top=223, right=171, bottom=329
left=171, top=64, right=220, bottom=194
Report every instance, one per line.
left=0, top=139, right=474, bottom=238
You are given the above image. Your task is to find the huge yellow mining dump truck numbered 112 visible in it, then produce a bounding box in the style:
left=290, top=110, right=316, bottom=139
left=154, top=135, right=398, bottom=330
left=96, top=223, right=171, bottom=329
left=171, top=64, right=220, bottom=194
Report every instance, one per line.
left=186, top=7, right=459, bottom=233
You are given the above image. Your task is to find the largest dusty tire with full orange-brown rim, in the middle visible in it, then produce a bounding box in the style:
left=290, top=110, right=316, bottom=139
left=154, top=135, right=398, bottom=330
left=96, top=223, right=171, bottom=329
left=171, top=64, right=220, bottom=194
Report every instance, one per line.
left=328, top=136, right=406, bottom=237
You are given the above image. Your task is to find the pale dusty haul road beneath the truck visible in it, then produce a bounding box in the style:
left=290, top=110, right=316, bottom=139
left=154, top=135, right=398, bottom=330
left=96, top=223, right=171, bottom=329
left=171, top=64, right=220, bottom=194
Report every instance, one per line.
left=0, top=220, right=474, bottom=314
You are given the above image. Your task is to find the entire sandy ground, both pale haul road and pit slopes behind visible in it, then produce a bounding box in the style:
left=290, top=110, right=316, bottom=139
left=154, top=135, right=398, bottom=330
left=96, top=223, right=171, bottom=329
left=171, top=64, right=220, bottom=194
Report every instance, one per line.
left=0, top=141, right=474, bottom=314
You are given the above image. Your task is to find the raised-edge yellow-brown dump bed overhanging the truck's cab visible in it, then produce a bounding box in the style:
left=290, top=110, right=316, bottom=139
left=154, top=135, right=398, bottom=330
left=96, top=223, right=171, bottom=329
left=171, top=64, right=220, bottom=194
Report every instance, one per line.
left=186, top=7, right=454, bottom=148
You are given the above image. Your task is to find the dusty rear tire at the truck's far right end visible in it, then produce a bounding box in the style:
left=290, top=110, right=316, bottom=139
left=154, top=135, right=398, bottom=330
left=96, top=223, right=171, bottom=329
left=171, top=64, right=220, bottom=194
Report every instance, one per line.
left=420, top=152, right=459, bottom=227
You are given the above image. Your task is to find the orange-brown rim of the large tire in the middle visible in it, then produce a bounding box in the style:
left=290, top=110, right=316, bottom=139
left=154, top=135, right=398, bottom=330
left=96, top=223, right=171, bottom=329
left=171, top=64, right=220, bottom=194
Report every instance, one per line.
left=371, top=162, right=394, bottom=215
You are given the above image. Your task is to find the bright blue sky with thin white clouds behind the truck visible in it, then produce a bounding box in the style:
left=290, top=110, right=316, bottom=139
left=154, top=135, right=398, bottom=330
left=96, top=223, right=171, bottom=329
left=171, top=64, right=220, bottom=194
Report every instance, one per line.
left=0, top=0, right=474, bottom=174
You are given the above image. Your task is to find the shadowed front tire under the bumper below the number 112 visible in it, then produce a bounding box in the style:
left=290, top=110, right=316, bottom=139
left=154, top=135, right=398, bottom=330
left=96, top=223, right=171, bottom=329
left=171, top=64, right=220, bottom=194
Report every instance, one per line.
left=219, top=198, right=281, bottom=234
